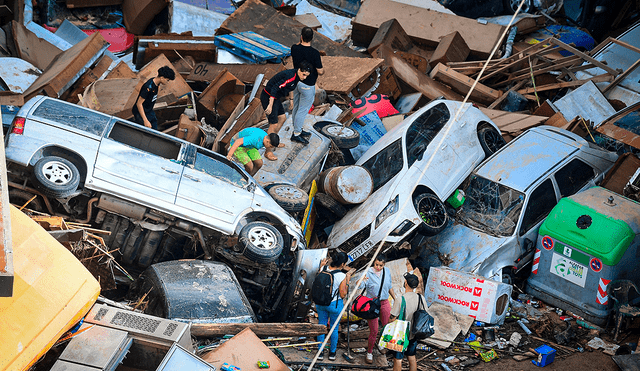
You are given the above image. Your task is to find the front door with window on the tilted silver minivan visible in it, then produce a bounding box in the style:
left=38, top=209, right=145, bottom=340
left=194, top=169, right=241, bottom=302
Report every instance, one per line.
left=176, top=148, right=253, bottom=229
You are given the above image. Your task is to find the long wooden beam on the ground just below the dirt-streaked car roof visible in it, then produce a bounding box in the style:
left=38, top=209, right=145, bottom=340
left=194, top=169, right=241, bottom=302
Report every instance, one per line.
left=191, top=323, right=327, bottom=337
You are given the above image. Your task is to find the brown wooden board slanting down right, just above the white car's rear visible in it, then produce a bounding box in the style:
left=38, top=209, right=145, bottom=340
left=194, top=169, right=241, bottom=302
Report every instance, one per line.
left=374, top=45, right=463, bottom=101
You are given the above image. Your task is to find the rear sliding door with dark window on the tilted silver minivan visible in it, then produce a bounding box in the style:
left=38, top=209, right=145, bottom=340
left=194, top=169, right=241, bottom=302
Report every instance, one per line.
left=92, top=122, right=184, bottom=204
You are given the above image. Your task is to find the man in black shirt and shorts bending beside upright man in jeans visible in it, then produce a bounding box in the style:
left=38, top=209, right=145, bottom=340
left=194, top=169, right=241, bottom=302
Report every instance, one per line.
left=260, top=61, right=312, bottom=161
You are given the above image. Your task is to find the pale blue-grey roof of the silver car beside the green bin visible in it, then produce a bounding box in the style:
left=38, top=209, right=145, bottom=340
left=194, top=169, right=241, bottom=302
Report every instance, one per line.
left=475, top=128, right=581, bottom=192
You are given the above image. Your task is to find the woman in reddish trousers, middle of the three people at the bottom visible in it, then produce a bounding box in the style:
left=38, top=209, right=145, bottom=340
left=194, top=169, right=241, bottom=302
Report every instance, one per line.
left=360, top=253, right=396, bottom=364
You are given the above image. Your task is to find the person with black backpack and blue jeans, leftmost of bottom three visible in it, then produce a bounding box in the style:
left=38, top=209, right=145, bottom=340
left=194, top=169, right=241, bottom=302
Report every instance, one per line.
left=311, top=251, right=352, bottom=361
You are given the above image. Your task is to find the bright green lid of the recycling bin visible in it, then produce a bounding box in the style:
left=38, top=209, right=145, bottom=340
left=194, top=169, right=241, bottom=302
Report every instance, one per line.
left=538, top=198, right=635, bottom=266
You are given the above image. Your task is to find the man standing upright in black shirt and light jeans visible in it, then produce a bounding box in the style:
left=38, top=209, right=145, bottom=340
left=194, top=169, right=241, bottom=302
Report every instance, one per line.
left=291, top=27, right=324, bottom=144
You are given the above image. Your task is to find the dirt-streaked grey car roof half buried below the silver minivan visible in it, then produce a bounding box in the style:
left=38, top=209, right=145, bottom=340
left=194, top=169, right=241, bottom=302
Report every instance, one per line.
left=148, top=260, right=256, bottom=322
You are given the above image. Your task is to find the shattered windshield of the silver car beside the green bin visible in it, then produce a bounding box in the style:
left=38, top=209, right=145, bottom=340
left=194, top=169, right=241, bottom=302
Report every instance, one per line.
left=458, top=175, right=524, bottom=237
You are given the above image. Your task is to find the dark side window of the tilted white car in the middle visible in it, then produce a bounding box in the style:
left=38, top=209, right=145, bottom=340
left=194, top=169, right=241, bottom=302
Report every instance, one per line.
left=407, top=103, right=451, bottom=167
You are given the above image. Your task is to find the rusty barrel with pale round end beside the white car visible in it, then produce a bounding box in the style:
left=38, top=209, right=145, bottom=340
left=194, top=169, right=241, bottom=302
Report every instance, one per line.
left=318, top=165, right=373, bottom=205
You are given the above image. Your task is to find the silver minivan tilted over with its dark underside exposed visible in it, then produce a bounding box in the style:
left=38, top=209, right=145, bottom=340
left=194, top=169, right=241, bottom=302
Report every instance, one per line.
left=5, top=96, right=326, bottom=320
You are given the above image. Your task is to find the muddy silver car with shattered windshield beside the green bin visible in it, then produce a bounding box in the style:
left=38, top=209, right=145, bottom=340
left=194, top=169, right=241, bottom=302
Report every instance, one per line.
left=414, top=126, right=618, bottom=282
